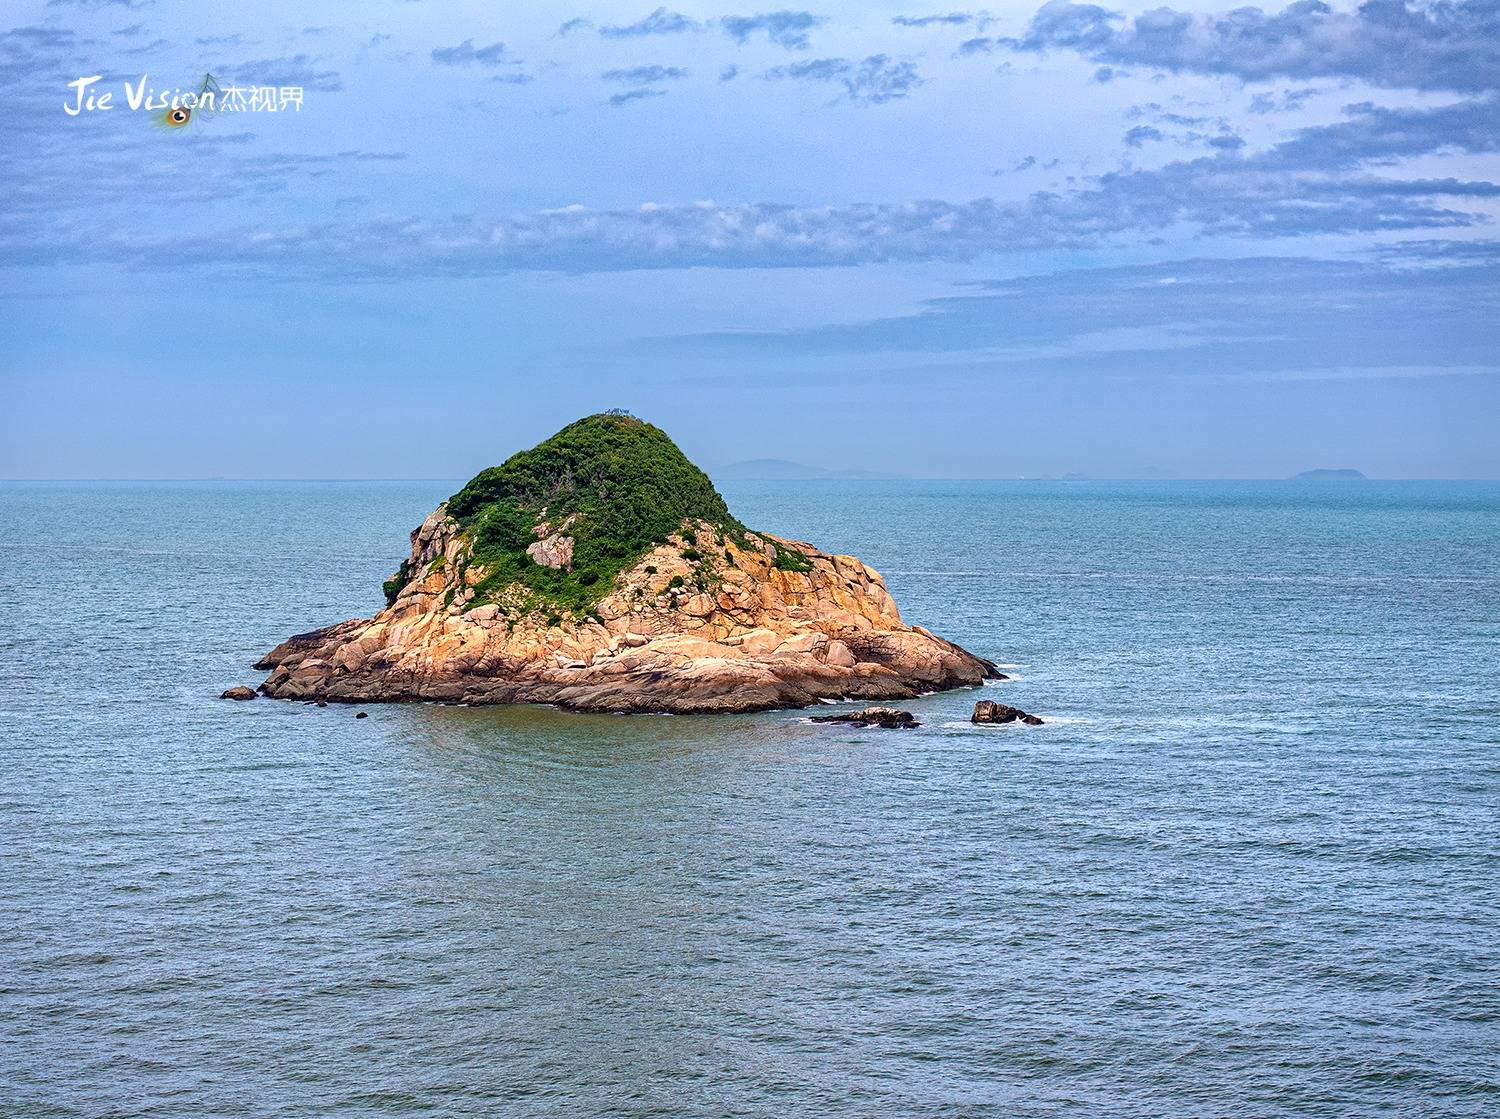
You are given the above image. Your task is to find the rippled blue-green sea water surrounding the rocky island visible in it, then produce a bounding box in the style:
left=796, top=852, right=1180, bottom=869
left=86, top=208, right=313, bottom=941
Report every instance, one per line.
left=0, top=482, right=1500, bottom=1119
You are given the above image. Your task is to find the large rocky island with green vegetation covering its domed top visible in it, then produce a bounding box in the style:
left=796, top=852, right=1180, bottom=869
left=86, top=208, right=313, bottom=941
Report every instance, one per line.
left=257, top=413, right=1001, bottom=713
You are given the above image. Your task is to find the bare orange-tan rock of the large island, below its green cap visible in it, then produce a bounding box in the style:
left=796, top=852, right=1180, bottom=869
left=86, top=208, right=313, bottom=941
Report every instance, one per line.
left=257, top=411, right=1001, bottom=713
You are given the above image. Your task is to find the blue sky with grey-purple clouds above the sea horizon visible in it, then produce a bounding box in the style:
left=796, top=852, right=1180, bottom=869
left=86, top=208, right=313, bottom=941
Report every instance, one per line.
left=0, top=0, right=1500, bottom=479
